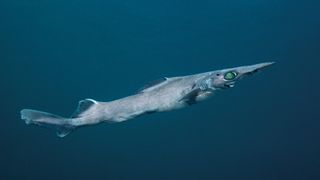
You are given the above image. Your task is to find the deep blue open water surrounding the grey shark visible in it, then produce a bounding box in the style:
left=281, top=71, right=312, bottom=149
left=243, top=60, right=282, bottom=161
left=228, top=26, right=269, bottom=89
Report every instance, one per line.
left=0, top=0, right=320, bottom=180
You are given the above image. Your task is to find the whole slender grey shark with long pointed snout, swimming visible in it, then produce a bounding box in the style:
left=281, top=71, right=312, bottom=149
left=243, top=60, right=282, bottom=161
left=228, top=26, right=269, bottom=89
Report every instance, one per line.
left=21, top=62, right=273, bottom=137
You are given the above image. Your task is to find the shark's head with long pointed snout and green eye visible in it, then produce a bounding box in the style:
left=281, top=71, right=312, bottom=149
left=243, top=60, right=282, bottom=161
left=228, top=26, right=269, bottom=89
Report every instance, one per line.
left=210, top=62, right=274, bottom=89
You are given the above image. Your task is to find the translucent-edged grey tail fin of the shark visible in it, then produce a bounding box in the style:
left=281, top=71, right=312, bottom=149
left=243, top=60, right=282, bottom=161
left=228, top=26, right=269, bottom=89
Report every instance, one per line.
left=20, top=109, right=75, bottom=137
